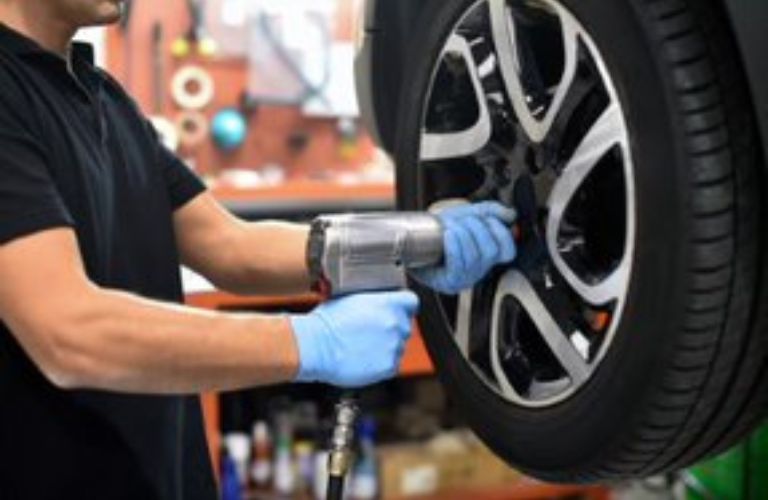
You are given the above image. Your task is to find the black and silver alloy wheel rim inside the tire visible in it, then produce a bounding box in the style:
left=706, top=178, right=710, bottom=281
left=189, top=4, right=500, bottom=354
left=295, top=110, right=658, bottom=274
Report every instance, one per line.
left=418, top=0, right=635, bottom=407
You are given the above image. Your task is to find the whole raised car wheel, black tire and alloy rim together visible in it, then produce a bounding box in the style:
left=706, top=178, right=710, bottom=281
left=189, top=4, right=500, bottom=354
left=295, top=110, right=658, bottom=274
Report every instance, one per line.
left=394, top=0, right=768, bottom=482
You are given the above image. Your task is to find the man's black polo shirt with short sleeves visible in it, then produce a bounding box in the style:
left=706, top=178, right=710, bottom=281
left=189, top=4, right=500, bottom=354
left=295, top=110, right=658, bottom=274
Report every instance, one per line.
left=0, top=27, right=216, bottom=500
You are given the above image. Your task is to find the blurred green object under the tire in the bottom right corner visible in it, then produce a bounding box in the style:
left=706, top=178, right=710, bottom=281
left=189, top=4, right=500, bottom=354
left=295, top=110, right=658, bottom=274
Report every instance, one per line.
left=688, top=425, right=768, bottom=500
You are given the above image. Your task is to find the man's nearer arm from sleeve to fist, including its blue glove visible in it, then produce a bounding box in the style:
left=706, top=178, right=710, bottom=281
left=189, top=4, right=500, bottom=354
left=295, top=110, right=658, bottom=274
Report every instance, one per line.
left=0, top=228, right=418, bottom=394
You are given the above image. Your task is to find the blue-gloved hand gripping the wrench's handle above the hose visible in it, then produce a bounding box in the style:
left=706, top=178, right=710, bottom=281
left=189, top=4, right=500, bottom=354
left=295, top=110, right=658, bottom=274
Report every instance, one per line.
left=291, top=291, right=419, bottom=388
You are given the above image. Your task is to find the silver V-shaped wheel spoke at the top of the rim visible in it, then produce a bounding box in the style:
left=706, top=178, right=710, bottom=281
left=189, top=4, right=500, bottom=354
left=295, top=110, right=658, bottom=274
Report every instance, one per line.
left=489, top=0, right=579, bottom=143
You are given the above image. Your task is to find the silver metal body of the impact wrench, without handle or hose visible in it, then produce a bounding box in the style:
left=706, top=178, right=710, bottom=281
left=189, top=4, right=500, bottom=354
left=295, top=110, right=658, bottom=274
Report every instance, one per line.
left=319, top=212, right=443, bottom=295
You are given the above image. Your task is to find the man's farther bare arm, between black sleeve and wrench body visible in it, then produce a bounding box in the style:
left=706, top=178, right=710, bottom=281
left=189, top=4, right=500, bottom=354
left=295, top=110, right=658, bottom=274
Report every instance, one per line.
left=174, top=193, right=310, bottom=295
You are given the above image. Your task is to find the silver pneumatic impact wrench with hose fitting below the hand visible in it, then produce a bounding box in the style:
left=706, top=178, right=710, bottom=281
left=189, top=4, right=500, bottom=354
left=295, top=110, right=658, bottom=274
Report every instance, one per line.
left=307, top=212, right=443, bottom=500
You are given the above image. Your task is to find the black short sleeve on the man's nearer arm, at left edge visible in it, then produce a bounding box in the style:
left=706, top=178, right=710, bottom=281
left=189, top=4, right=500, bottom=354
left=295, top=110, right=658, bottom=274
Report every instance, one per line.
left=0, top=123, right=74, bottom=244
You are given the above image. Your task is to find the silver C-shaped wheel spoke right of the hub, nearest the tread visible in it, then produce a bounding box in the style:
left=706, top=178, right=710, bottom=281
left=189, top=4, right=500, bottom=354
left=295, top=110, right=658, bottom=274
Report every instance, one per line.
left=547, top=104, right=628, bottom=305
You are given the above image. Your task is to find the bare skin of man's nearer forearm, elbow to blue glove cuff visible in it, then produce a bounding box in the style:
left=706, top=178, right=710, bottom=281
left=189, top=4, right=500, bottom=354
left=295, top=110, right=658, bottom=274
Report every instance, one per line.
left=49, top=289, right=298, bottom=394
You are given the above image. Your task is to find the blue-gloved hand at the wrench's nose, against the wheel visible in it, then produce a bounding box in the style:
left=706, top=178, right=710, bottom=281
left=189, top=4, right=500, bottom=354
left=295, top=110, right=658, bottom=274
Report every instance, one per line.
left=412, top=202, right=517, bottom=295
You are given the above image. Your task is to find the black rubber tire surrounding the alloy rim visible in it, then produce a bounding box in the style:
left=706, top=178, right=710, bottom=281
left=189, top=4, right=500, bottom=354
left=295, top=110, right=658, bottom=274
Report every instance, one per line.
left=395, top=0, right=768, bottom=482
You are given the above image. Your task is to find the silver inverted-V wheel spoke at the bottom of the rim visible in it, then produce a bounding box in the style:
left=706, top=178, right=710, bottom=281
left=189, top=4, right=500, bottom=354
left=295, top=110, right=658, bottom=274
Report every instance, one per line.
left=490, top=269, right=590, bottom=398
